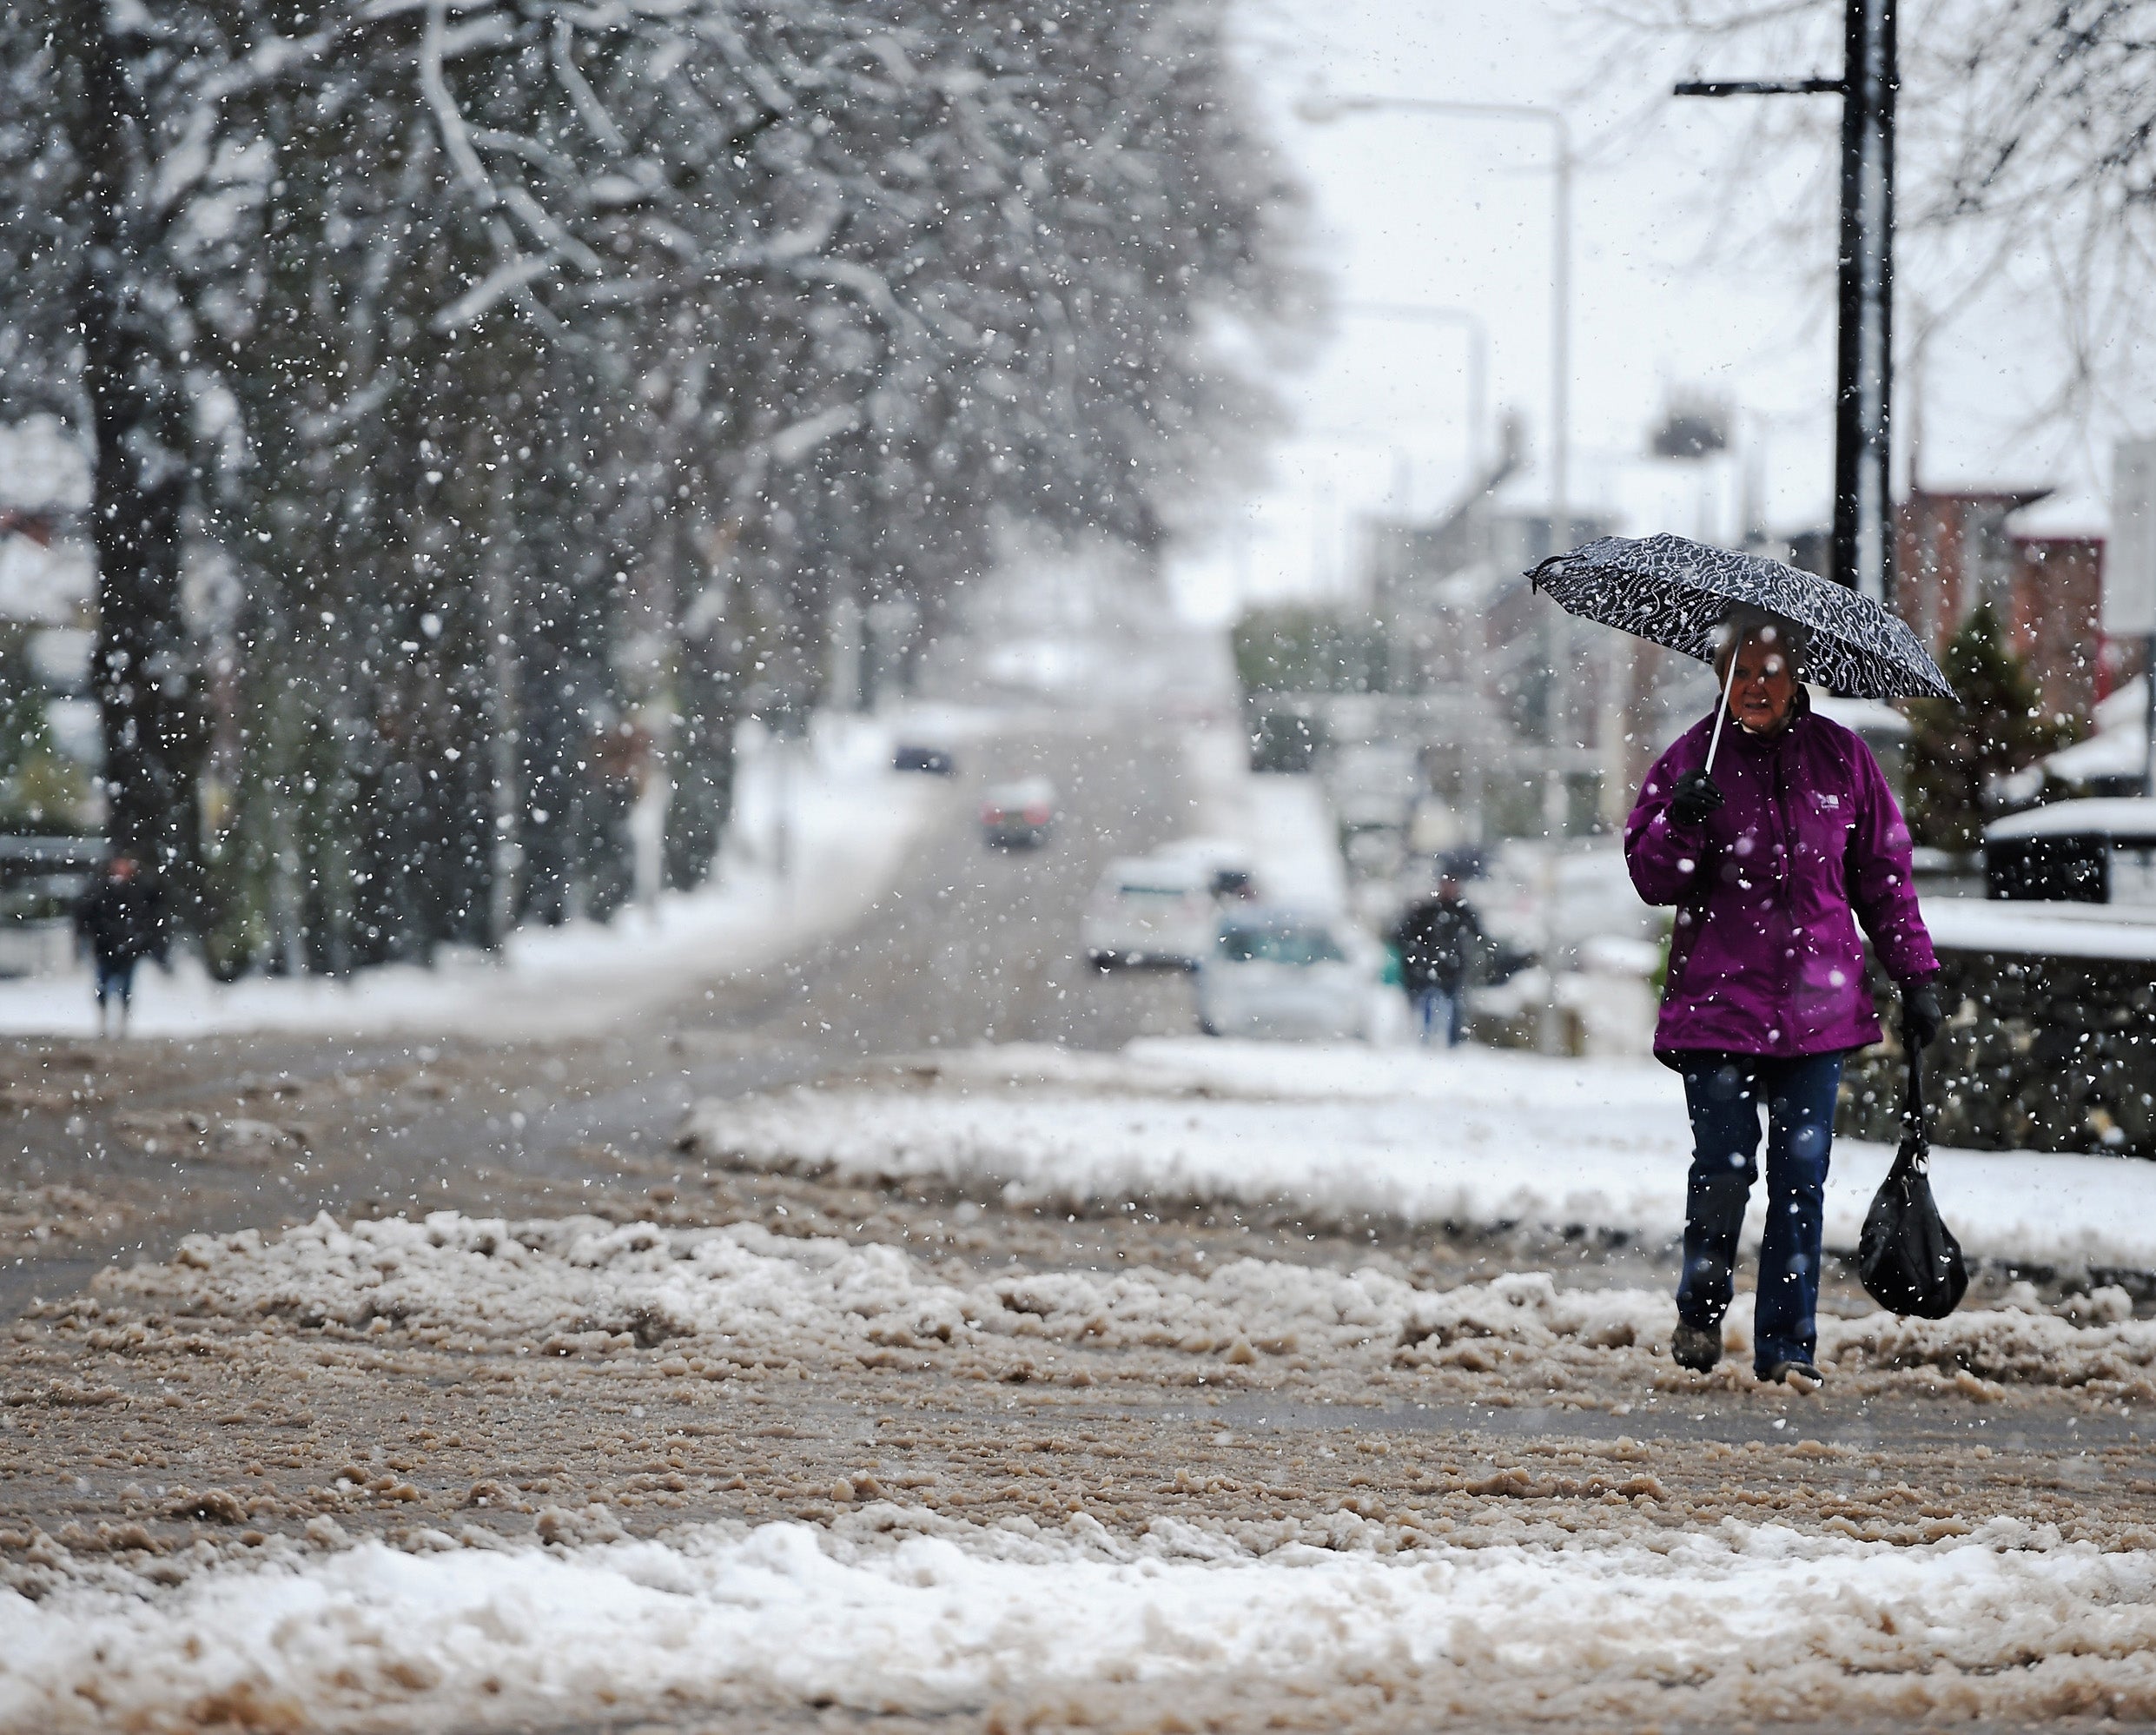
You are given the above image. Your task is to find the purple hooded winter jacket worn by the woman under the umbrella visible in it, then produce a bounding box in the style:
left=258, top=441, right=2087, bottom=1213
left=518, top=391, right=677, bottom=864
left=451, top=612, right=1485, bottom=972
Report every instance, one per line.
left=1624, top=690, right=1938, bottom=1056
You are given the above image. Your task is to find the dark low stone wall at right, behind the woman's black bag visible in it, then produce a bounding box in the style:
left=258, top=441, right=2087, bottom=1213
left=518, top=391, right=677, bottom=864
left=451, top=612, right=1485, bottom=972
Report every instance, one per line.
left=1842, top=950, right=2156, bottom=1157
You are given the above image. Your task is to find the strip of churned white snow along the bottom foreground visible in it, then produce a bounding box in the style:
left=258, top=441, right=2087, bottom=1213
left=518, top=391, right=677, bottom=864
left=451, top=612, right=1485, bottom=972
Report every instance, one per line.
left=0, top=1505, right=2156, bottom=1731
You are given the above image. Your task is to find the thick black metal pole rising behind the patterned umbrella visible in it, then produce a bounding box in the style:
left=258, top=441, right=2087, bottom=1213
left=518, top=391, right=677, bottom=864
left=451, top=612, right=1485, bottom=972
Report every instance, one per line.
left=1833, top=0, right=1900, bottom=606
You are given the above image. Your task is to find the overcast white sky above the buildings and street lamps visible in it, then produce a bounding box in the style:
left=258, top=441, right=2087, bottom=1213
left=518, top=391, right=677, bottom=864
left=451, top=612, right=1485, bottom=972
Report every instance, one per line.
left=1177, top=0, right=2139, bottom=614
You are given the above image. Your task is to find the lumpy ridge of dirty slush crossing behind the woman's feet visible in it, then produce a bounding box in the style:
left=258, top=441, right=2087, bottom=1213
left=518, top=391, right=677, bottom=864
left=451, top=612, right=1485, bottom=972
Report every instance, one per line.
left=93, top=1211, right=2156, bottom=1388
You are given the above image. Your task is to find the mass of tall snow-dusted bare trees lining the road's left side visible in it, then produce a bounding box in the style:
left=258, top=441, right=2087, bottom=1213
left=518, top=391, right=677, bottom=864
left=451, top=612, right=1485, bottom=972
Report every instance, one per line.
left=0, top=0, right=1293, bottom=970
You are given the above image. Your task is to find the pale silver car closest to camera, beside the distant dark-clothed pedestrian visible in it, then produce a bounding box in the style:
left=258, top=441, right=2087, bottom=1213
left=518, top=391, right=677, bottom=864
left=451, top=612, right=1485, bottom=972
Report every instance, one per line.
left=1197, top=905, right=1376, bottom=1041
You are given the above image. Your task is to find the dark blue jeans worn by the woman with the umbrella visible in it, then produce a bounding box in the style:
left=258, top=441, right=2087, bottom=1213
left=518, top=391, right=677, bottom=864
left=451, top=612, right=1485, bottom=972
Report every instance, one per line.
left=1677, top=1052, right=1842, bottom=1375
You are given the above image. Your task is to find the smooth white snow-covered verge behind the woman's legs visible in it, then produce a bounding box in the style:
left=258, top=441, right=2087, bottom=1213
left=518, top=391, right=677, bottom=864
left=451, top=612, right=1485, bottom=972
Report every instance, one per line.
left=684, top=1039, right=2156, bottom=1272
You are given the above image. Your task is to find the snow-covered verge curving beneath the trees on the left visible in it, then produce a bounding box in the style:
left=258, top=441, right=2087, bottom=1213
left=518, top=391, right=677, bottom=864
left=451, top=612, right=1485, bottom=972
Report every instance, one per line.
left=0, top=713, right=979, bottom=1039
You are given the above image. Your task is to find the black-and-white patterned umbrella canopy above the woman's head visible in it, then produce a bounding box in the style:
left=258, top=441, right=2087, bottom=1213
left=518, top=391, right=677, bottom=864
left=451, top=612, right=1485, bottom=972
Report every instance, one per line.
left=1531, top=530, right=1954, bottom=699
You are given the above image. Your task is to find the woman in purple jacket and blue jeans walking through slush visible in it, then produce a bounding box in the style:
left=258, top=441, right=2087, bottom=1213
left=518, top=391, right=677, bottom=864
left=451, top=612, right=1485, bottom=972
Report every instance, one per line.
left=1625, top=616, right=1941, bottom=1390
